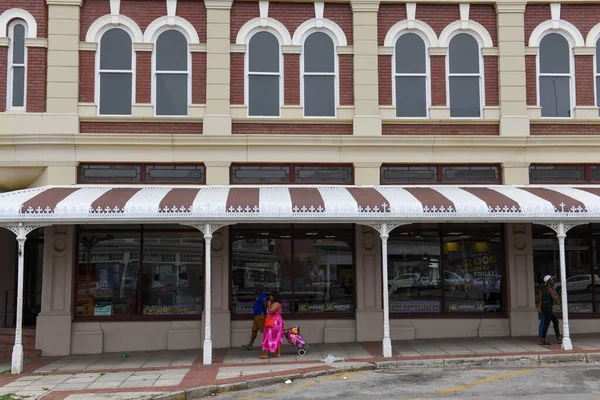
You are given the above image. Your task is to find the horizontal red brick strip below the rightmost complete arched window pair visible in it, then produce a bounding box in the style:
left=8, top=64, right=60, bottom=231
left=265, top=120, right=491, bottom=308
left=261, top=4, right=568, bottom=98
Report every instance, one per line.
left=382, top=124, right=500, bottom=136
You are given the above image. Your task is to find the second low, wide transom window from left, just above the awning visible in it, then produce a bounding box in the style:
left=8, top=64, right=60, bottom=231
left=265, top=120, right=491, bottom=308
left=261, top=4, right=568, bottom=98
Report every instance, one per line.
left=231, top=164, right=354, bottom=185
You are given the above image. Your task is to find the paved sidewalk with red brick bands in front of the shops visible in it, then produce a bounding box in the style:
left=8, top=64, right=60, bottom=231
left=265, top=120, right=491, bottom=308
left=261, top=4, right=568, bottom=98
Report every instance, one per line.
left=0, top=335, right=600, bottom=400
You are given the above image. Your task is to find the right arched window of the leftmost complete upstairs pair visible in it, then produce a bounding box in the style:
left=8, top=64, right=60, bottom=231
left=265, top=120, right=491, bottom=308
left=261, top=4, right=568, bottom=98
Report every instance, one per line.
left=154, top=30, right=191, bottom=115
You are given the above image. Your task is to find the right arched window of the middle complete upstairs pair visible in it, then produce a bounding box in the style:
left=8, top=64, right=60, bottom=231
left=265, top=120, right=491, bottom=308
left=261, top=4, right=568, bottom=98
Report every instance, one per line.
left=302, top=32, right=338, bottom=117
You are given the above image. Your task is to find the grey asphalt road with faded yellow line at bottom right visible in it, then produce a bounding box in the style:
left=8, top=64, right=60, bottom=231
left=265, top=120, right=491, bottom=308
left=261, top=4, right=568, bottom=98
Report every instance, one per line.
left=211, top=364, right=600, bottom=400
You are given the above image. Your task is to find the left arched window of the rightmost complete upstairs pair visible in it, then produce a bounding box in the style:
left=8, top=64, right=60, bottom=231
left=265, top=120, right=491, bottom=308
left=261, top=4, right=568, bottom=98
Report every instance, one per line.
left=394, top=33, right=429, bottom=117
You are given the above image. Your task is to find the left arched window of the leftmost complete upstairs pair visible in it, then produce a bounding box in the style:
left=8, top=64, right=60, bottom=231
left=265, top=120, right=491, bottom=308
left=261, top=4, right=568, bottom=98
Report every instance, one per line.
left=97, top=28, right=134, bottom=115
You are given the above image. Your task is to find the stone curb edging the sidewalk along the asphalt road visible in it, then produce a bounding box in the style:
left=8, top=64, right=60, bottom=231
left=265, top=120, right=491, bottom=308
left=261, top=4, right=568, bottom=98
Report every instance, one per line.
left=152, top=353, right=600, bottom=400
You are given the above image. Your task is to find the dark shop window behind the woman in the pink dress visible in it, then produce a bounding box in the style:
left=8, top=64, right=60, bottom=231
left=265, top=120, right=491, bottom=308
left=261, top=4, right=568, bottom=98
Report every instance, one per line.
left=231, top=225, right=355, bottom=317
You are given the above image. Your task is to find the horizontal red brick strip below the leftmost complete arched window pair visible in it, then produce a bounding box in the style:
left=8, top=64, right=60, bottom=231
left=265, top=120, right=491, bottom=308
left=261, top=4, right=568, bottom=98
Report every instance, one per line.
left=79, top=121, right=202, bottom=134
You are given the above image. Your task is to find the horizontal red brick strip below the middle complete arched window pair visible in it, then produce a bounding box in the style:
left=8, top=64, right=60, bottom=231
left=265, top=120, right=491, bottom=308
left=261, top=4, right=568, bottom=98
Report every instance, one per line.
left=231, top=123, right=353, bottom=135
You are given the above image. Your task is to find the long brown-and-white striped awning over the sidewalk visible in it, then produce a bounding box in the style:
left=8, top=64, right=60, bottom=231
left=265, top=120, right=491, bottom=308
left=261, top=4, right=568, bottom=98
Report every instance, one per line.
left=0, top=185, right=600, bottom=223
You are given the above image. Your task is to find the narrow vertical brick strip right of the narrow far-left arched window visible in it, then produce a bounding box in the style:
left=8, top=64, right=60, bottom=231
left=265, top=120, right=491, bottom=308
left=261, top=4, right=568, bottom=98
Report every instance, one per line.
left=27, top=47, right=47, bottom=112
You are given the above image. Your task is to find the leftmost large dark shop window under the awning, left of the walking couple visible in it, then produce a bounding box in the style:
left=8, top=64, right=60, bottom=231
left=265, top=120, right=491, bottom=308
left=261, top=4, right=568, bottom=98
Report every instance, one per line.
left=75, top=225, right=204, bottom=318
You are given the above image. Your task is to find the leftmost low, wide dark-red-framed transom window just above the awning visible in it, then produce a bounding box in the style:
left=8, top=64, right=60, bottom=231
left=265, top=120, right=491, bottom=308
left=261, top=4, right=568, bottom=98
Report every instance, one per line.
left=79, top=164, right=206, bottom=184
